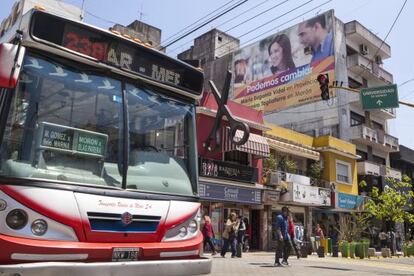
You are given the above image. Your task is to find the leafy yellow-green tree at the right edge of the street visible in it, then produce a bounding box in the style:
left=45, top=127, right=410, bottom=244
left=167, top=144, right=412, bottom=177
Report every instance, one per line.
left=365, top=175, right=414, bottom=226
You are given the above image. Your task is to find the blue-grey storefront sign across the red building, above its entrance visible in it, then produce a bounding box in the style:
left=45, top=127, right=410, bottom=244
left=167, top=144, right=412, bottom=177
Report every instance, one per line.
left=199, top=181, right=262, bottom=204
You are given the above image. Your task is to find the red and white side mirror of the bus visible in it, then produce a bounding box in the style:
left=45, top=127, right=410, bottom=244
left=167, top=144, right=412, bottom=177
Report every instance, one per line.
left=0, top=43, right=26, bottom=88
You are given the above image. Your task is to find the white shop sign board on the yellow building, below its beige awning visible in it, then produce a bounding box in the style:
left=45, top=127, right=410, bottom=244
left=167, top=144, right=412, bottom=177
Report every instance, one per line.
left=280, top=183, right=331, bottom=206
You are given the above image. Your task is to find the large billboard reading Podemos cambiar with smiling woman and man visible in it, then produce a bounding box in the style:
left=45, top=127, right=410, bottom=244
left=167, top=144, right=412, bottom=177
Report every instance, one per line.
left=232, top=10, right=335, bottom=114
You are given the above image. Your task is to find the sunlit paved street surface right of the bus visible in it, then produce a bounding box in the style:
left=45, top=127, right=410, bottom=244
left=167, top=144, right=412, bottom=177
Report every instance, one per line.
left=202, top=252, right=414, bottom=276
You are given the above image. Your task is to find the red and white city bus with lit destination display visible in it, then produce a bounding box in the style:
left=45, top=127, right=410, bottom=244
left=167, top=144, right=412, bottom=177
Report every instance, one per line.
left=0, top=2, right=211, bottom=276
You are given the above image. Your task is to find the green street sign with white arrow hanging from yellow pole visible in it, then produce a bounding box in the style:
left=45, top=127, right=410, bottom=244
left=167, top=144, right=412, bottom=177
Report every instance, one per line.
left=361, top=84, right=398, bottom=109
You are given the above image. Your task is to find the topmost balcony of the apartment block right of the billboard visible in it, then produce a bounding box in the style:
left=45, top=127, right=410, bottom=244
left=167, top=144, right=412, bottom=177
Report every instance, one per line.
left=345, top=20, right=391, bottom=59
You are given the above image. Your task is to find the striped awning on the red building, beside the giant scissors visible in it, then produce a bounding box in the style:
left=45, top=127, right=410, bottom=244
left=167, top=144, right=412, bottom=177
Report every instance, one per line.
left=223, top=127, right=270, bottom=158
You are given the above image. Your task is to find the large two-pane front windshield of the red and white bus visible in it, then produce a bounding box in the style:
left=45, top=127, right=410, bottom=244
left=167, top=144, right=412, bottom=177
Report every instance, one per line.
left=0, top=55, right=196, bottom=195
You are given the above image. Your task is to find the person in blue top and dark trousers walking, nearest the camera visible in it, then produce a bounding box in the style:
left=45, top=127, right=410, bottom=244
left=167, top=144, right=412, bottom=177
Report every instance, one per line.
left=274, top=206, right=290, bottom=267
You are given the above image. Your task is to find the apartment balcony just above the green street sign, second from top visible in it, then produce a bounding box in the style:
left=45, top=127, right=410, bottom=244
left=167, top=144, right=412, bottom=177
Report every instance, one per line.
left=346, top=53, right=393, bottom=86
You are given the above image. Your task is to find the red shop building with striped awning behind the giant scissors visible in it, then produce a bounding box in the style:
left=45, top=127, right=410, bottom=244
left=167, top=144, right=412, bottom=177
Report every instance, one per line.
left=197, top=93, right=269, bottom=249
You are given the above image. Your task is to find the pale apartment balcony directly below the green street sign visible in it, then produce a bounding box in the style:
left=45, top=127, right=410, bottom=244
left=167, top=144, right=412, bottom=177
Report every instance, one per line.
left=351, top=125, right=399, bottom=152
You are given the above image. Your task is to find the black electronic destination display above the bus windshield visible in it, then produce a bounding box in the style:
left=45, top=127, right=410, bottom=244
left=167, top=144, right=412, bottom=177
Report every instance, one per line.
left=31, top=12, right=203, bottom=95
